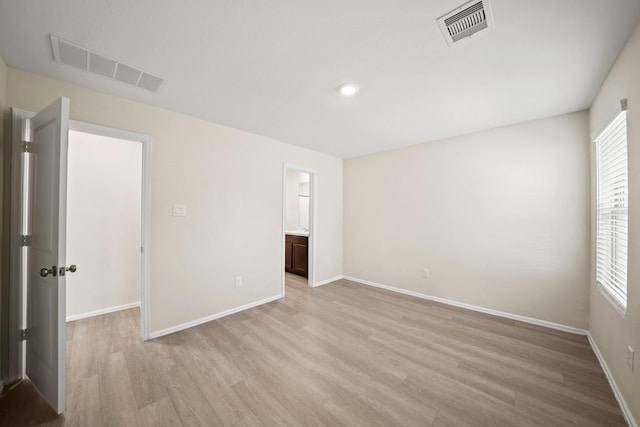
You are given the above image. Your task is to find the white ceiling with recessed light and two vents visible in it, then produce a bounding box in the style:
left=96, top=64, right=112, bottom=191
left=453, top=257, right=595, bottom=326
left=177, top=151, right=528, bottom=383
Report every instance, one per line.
left=0, top=0, right=640, bottom=158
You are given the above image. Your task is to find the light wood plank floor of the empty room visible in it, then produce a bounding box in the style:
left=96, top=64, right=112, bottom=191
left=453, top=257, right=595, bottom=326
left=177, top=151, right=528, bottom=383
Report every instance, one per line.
left=0, top=275, right=626, bottom=426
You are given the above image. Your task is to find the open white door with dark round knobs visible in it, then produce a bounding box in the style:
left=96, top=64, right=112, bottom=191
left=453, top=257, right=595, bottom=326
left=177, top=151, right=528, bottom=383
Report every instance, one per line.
left=22, top=98, right=70, bottom=413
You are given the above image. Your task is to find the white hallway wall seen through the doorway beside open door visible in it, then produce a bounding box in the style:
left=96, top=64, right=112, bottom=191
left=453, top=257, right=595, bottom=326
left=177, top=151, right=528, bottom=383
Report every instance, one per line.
left=66, top=131, right=142, bottom=316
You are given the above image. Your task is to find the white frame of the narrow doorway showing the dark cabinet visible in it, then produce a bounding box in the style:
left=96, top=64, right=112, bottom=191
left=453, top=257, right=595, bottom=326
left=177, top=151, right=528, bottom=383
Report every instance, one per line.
left=281, top=163, right=317, bottom=297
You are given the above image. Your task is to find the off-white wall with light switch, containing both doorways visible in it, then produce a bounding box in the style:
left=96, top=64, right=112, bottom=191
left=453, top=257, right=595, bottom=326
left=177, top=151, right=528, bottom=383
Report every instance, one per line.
left=7, top=68, right=342, bottom=332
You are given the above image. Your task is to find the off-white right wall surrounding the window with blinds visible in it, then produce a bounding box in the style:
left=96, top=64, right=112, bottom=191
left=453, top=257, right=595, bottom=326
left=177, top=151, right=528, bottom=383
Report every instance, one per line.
left=589, top=19, right=640, bottom=422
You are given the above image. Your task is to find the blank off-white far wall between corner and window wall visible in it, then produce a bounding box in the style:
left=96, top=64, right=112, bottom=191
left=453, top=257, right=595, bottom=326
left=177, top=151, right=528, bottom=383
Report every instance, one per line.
left=344, top=112, right=589, bottom=328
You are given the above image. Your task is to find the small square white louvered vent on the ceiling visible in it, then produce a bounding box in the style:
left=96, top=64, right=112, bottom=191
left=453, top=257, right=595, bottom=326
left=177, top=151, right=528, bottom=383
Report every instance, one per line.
left=438, top=0, right=494, bottom=46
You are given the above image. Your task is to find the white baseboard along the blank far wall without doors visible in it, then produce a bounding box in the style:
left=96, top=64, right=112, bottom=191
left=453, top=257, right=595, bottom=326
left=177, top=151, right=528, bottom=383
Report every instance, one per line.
left=344, top=276, right=588, bottom=335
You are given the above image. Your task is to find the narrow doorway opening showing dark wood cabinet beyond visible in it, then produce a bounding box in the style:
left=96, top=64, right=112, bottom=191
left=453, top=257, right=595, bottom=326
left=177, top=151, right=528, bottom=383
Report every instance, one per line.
left=282, top=164, right=315, bottom=296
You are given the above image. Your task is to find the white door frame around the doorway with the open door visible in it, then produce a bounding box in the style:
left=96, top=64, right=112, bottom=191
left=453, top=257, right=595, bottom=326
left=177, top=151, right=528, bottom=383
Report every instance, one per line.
left=7, top=108, right=152, bottom=383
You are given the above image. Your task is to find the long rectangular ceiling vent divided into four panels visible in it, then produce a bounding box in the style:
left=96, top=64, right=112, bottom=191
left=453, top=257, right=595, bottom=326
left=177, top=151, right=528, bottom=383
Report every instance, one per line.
left=51, top=35, right=164, bottom=93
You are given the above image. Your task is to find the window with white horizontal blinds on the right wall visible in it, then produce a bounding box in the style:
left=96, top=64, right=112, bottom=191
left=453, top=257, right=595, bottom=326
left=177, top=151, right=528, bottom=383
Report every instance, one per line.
left=595, top=101, right=629, bottom=313
